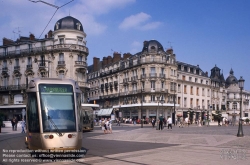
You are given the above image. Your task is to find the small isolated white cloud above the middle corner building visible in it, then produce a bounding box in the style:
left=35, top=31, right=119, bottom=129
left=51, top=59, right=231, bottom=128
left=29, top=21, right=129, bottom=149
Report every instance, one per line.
left=119, top=12, right=161, bottom=30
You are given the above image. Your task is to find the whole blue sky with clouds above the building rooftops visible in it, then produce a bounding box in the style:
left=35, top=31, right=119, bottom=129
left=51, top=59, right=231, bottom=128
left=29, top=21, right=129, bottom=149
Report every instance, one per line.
left=0, top=0, right=250, bottom=91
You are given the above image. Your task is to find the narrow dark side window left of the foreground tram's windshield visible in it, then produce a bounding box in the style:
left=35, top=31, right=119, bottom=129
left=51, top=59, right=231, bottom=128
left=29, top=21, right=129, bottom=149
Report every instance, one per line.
left=27, top=92, right=40, bottom=132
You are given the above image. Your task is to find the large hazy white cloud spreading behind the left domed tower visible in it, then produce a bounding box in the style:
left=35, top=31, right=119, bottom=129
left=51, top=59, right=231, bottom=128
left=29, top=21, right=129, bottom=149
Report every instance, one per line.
left=0, top=0, right=136, bottom=39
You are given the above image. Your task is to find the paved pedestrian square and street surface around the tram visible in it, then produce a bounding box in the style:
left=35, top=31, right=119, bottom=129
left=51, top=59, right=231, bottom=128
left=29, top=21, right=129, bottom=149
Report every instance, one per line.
left=0, top=124, right=250, bottom=165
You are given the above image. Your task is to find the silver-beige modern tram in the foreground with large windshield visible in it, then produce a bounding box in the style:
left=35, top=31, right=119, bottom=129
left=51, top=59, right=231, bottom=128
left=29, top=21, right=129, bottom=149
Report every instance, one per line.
left=25, top=78, right=83, bottom=151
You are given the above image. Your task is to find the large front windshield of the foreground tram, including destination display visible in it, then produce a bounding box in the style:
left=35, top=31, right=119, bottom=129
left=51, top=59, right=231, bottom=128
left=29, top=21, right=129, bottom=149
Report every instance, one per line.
left=39, top=84, right=76, bottom=133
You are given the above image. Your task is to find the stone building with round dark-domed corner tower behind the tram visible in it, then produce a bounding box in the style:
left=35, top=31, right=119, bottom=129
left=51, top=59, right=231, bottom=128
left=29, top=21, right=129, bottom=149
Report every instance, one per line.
left=0, top=16, right=89, bottom=120
